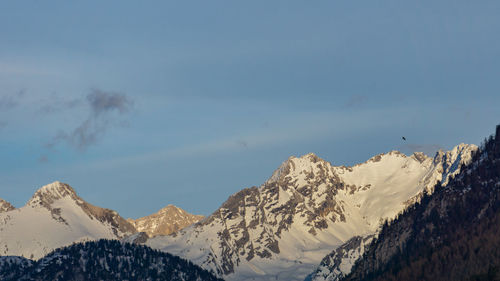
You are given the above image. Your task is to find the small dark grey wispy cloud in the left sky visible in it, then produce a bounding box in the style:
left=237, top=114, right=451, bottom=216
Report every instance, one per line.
left=47, top=89, right=133, bottom=151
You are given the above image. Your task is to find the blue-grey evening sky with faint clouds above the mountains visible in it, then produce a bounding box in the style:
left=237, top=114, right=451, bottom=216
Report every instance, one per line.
left=0, top=0, right=500, bottom=218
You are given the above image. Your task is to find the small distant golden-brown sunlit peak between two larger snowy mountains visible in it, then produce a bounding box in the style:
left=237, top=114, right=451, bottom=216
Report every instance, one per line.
left=127, top=205, right=204, bottom=237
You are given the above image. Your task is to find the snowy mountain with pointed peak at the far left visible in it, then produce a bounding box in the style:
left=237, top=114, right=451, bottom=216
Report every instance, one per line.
left=0, top=182, right=136, bottom=259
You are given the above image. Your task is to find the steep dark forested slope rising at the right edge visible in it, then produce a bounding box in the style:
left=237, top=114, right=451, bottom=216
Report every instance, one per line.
left=343, top=126, right=500, bottom=281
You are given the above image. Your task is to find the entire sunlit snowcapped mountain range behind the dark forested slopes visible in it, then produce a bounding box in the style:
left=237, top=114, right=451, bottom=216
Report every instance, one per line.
left=0, top=144, right=477, bottom=280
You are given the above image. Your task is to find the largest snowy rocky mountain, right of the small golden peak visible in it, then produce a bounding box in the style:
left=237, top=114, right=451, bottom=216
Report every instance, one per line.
left=146, top=144, right=477, bottom=280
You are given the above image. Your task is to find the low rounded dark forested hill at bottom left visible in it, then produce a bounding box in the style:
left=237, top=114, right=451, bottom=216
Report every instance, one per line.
left=0, top=239, right=222, bottom=281
